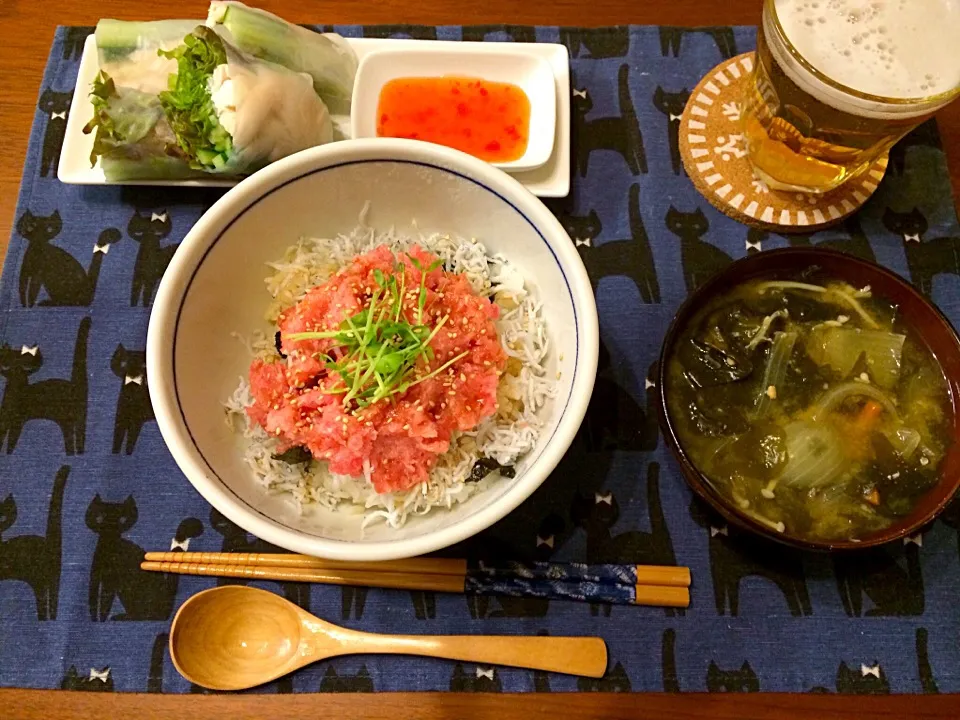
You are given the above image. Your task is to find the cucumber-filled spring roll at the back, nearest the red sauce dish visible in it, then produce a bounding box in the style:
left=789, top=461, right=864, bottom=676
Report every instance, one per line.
left=207, top=0, right=357, bottom=115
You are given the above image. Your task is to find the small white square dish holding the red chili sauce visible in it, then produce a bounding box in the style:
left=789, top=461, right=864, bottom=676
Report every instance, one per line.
left=350, top=42, right=557, bottom=172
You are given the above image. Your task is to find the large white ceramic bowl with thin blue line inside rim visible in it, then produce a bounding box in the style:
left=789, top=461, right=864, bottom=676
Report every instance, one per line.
left=147, top=139, right=598, bottom=561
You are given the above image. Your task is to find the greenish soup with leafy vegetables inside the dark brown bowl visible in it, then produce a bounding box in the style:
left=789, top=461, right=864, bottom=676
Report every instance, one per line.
left=666, top=276, right=953, bottom=541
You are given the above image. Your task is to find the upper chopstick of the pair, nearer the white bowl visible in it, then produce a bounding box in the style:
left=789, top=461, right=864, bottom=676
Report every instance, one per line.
left=145, top=552, right=691, bottom=587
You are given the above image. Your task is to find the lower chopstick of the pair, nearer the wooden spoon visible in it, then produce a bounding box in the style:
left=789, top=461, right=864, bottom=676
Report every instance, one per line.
left=140, top=552, right=690, bottom=607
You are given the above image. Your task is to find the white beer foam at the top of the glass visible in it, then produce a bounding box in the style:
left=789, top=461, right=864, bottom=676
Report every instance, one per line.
left=764, top=0, right=960, bottom=116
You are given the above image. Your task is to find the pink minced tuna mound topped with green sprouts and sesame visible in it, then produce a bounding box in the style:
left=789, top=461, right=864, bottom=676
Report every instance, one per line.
left=247, top=245, right=506, bottom=493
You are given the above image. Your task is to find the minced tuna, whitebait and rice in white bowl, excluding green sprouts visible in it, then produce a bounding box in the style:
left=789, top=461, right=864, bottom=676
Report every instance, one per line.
left=225, top=212, right=559, bottom=528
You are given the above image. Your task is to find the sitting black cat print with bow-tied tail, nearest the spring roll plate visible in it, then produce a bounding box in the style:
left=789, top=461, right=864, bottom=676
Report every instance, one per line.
left=17, top=210, right=122, bottom=307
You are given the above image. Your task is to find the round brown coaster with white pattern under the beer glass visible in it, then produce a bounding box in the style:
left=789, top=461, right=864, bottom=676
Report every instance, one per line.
left=680, top=52, right=887, bottom=233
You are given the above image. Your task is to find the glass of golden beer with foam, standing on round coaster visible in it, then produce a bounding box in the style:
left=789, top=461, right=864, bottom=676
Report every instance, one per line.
left=741, top=0, right=960, bottom=193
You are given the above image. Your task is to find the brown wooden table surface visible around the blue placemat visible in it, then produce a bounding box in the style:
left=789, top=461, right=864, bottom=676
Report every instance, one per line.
left=0, top=0, right=960, bottom=720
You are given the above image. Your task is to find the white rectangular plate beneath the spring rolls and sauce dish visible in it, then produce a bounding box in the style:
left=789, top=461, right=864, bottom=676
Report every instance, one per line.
left=57, top=35, right=570, bottom=197
